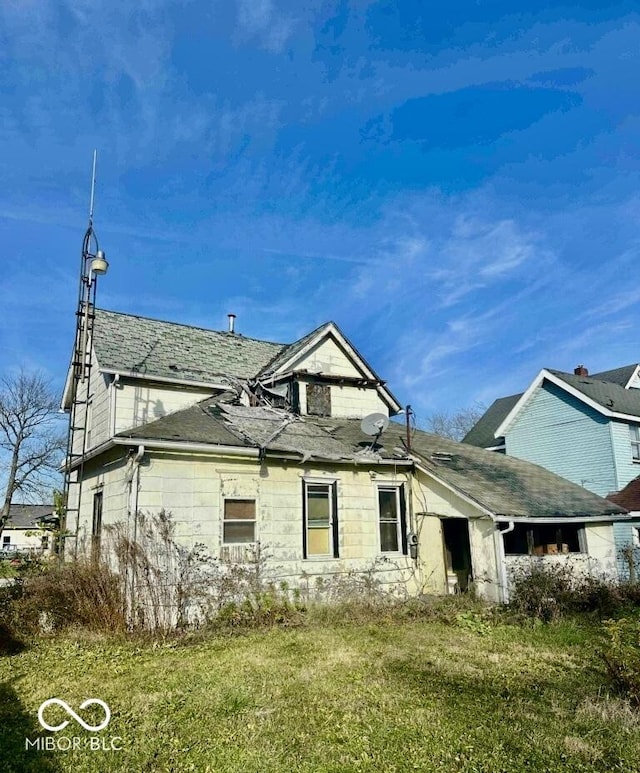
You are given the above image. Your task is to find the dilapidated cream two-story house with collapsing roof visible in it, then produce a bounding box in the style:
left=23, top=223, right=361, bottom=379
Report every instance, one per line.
left=63, top=309, right=626, bottom=600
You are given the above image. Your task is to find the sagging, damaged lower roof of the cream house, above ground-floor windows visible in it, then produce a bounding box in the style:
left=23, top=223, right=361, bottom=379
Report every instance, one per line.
left=119, top=398, right=625, bottom=520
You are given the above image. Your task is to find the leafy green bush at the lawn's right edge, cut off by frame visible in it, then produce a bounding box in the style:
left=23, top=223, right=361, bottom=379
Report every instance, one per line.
left=600, top=617, right=640, bottom=706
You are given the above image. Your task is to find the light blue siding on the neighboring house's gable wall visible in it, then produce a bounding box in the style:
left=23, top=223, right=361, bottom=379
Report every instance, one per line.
left=505, top=381, right=618, bottom=496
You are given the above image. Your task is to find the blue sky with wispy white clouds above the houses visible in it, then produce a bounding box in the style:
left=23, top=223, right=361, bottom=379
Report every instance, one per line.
left=0, top=0, right=640, bottom=422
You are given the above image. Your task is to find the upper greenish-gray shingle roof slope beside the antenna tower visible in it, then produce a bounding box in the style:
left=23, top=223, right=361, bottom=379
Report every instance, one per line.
left=94, top=309, right=286, bottom=383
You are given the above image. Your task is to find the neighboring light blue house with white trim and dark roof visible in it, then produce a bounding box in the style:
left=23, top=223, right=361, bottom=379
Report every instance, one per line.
left=463, top=363, right=640, bottom=576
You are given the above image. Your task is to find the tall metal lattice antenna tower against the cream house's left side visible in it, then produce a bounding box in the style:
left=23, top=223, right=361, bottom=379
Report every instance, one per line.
left=60, top=150, right=109, bottom=559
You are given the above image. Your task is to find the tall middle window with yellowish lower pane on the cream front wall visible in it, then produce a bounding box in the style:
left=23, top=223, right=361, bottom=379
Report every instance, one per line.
left=302, top=481, right=339, bottom=558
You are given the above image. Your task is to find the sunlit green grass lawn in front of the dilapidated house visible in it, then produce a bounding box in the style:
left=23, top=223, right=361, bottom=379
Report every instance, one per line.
left=0, top=621, right=640, bottom=773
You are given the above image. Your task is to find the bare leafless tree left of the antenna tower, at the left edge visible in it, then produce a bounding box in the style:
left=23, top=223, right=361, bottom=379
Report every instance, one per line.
left=0, top=371, right=65, bottom=534
